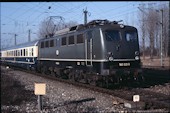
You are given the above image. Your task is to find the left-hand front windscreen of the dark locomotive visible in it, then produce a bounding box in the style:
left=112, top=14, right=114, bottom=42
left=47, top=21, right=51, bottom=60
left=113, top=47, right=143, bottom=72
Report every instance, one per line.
left=105, top=30, right=120, bottom=41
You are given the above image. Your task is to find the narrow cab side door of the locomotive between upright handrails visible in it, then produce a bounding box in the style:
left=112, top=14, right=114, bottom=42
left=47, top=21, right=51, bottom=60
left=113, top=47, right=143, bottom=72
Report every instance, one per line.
left=85, top=31, right=93, bottom=66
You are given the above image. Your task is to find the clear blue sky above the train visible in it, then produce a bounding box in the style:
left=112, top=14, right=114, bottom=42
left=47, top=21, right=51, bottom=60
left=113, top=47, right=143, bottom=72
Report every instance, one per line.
left=0, top=1, right=168, bottom=48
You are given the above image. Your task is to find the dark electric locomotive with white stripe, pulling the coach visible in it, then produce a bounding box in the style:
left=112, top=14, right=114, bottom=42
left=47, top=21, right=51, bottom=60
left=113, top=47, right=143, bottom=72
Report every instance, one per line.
left=37, top=20, right=142, bottom=84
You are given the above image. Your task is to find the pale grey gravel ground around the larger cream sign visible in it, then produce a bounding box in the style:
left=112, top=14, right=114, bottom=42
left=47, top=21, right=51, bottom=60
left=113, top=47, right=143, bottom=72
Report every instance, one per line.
left=1, top=67, right=170, bottom=113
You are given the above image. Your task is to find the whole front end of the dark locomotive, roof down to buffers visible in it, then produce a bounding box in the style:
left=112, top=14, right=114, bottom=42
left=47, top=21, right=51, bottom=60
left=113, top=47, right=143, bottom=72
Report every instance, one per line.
left=96, top=24, right=142, bottom=83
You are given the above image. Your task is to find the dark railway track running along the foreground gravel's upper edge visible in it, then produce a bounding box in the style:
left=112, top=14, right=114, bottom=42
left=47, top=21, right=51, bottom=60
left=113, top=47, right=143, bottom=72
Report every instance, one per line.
left=3, top=67, right=170, bottom=111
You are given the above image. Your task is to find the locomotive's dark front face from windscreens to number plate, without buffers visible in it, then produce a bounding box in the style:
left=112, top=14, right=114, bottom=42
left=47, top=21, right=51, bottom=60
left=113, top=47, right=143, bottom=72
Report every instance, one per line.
left=103, top=26, right=140, bottom=68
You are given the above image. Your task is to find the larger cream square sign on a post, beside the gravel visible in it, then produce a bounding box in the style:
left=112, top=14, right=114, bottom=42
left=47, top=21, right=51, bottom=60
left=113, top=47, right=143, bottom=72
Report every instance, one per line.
left=34, top=83, right=46, bottom=111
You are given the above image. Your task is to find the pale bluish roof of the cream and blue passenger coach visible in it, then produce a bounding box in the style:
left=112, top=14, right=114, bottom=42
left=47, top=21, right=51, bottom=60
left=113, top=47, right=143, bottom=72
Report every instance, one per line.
left=1, top=40, right=39, bottom=51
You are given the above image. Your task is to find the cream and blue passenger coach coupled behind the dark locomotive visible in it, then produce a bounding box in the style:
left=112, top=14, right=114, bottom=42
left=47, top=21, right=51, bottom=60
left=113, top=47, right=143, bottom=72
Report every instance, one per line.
left=1, top=41, right=38, bottom=70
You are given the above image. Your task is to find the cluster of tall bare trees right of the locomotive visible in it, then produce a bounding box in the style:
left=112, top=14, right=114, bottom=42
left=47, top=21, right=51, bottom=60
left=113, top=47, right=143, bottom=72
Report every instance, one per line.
left=138, top=3, right=169, bottom=59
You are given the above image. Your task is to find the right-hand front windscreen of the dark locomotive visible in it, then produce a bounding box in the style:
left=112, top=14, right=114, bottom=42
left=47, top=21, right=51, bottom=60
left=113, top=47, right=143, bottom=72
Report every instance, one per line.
left=125, top=31, right=137, bottom=42
